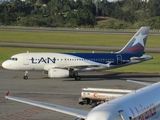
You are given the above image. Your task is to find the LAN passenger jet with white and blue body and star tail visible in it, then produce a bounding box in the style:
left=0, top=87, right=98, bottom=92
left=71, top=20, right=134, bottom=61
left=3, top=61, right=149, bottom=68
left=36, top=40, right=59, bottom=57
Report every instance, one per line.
left=2, top=27, right=152, bottom=80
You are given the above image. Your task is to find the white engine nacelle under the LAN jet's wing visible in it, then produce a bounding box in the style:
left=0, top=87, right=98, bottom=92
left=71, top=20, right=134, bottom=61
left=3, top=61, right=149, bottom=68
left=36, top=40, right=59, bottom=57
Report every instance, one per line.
left=48, top=68, right=69, bottom=78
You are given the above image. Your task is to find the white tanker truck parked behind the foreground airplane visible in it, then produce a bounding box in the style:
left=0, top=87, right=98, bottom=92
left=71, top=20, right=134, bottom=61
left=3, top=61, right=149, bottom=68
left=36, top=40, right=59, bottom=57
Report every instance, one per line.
left=79, top=88, right=134, bottom=107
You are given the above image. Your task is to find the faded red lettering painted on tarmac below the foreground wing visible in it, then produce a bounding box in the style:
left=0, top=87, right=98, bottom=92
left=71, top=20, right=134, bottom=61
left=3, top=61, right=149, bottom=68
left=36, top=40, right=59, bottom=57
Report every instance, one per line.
left=0, top=107, right=46, bottom=120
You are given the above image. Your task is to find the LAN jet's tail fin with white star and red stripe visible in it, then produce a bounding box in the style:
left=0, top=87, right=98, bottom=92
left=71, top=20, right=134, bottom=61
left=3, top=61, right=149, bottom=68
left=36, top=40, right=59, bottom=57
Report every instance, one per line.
left=118, top=27, right=150, bottom=55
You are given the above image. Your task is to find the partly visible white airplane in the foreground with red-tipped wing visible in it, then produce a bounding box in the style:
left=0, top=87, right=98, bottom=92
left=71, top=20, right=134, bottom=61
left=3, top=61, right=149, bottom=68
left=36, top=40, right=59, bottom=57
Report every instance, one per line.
left=5, top=82, right=160, bottom=120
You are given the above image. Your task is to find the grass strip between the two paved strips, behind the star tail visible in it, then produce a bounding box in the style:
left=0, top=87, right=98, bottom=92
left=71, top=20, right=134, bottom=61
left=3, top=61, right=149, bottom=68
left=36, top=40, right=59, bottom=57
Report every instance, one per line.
left=0, top=30, right=160, bottom=47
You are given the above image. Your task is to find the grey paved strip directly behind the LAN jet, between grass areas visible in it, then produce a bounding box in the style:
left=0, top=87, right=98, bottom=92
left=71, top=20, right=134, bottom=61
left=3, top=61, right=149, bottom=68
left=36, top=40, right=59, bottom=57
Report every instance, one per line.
left=0, top=42, right=160, bottom=53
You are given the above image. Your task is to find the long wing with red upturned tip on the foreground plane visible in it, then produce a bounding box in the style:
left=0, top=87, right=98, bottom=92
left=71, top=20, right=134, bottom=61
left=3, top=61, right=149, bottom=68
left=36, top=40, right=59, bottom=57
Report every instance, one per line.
left=5, top=92, right=88, bottom=119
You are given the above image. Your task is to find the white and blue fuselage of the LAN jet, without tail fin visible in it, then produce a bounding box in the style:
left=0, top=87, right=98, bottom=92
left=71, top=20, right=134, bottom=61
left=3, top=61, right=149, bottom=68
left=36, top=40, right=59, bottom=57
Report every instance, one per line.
left=8, top=53, right=149, bottom=71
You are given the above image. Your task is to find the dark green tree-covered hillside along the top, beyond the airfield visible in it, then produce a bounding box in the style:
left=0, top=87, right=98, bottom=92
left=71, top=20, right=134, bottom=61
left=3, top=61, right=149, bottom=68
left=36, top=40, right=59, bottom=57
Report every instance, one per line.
left=0, top=0, right=160, bottom=29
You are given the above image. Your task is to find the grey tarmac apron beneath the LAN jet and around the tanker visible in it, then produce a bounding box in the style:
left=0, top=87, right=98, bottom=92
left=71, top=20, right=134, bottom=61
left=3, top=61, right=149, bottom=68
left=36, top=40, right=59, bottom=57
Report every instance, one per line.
left=0, top=68, right=160, bottom=120
